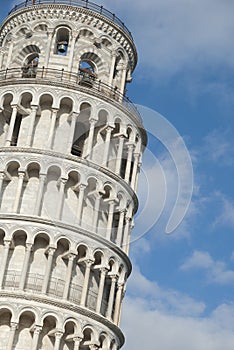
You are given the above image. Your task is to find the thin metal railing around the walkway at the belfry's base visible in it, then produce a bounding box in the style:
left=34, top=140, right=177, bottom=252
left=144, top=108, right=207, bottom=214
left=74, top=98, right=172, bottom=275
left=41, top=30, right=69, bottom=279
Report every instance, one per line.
left=0, top=67, right=142, bottom=121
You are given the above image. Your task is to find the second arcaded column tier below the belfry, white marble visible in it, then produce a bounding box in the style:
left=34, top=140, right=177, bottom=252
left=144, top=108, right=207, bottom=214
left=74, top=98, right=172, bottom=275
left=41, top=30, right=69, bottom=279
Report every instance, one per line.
left=0, top=147, right=138, bottom=253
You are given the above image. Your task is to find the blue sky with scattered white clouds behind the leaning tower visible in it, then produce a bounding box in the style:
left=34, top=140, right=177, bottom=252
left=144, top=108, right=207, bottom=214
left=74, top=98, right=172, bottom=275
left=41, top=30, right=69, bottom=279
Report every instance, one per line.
left=1, top=0, right=234, bottom=350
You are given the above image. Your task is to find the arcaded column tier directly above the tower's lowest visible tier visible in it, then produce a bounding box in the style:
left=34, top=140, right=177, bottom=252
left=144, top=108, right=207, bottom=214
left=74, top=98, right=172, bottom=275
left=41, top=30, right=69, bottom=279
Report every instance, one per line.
left=0, top=221, right=129, bottom=325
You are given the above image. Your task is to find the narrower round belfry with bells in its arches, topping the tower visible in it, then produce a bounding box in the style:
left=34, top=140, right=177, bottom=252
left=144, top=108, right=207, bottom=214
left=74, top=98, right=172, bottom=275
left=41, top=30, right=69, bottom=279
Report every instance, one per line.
left=0, top=1, right=137, bottom=93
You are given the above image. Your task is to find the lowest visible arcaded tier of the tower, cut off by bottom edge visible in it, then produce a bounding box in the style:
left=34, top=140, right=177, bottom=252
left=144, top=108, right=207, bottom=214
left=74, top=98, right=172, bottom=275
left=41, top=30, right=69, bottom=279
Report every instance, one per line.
left=0, top=293, right=124, bottom=350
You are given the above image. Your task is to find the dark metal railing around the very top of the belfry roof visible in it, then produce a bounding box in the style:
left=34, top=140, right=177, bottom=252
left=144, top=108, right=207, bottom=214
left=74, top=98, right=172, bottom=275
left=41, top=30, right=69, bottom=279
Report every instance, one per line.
left=9, top=0, right=132, bottom=39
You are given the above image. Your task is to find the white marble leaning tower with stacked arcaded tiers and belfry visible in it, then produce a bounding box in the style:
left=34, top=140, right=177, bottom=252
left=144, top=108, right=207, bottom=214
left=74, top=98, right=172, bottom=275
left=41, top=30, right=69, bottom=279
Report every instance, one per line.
left=0, top=0, right=146, bottom=350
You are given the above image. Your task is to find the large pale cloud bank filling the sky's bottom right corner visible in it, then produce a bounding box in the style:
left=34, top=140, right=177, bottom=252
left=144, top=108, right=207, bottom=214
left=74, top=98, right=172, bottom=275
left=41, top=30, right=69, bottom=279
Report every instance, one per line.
left=121, top=262, right=234, bottom=350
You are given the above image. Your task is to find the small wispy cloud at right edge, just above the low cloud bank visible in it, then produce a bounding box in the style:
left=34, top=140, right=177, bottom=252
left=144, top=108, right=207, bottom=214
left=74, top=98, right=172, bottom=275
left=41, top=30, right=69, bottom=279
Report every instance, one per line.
left=180, top=251, right=234, bottom=285
